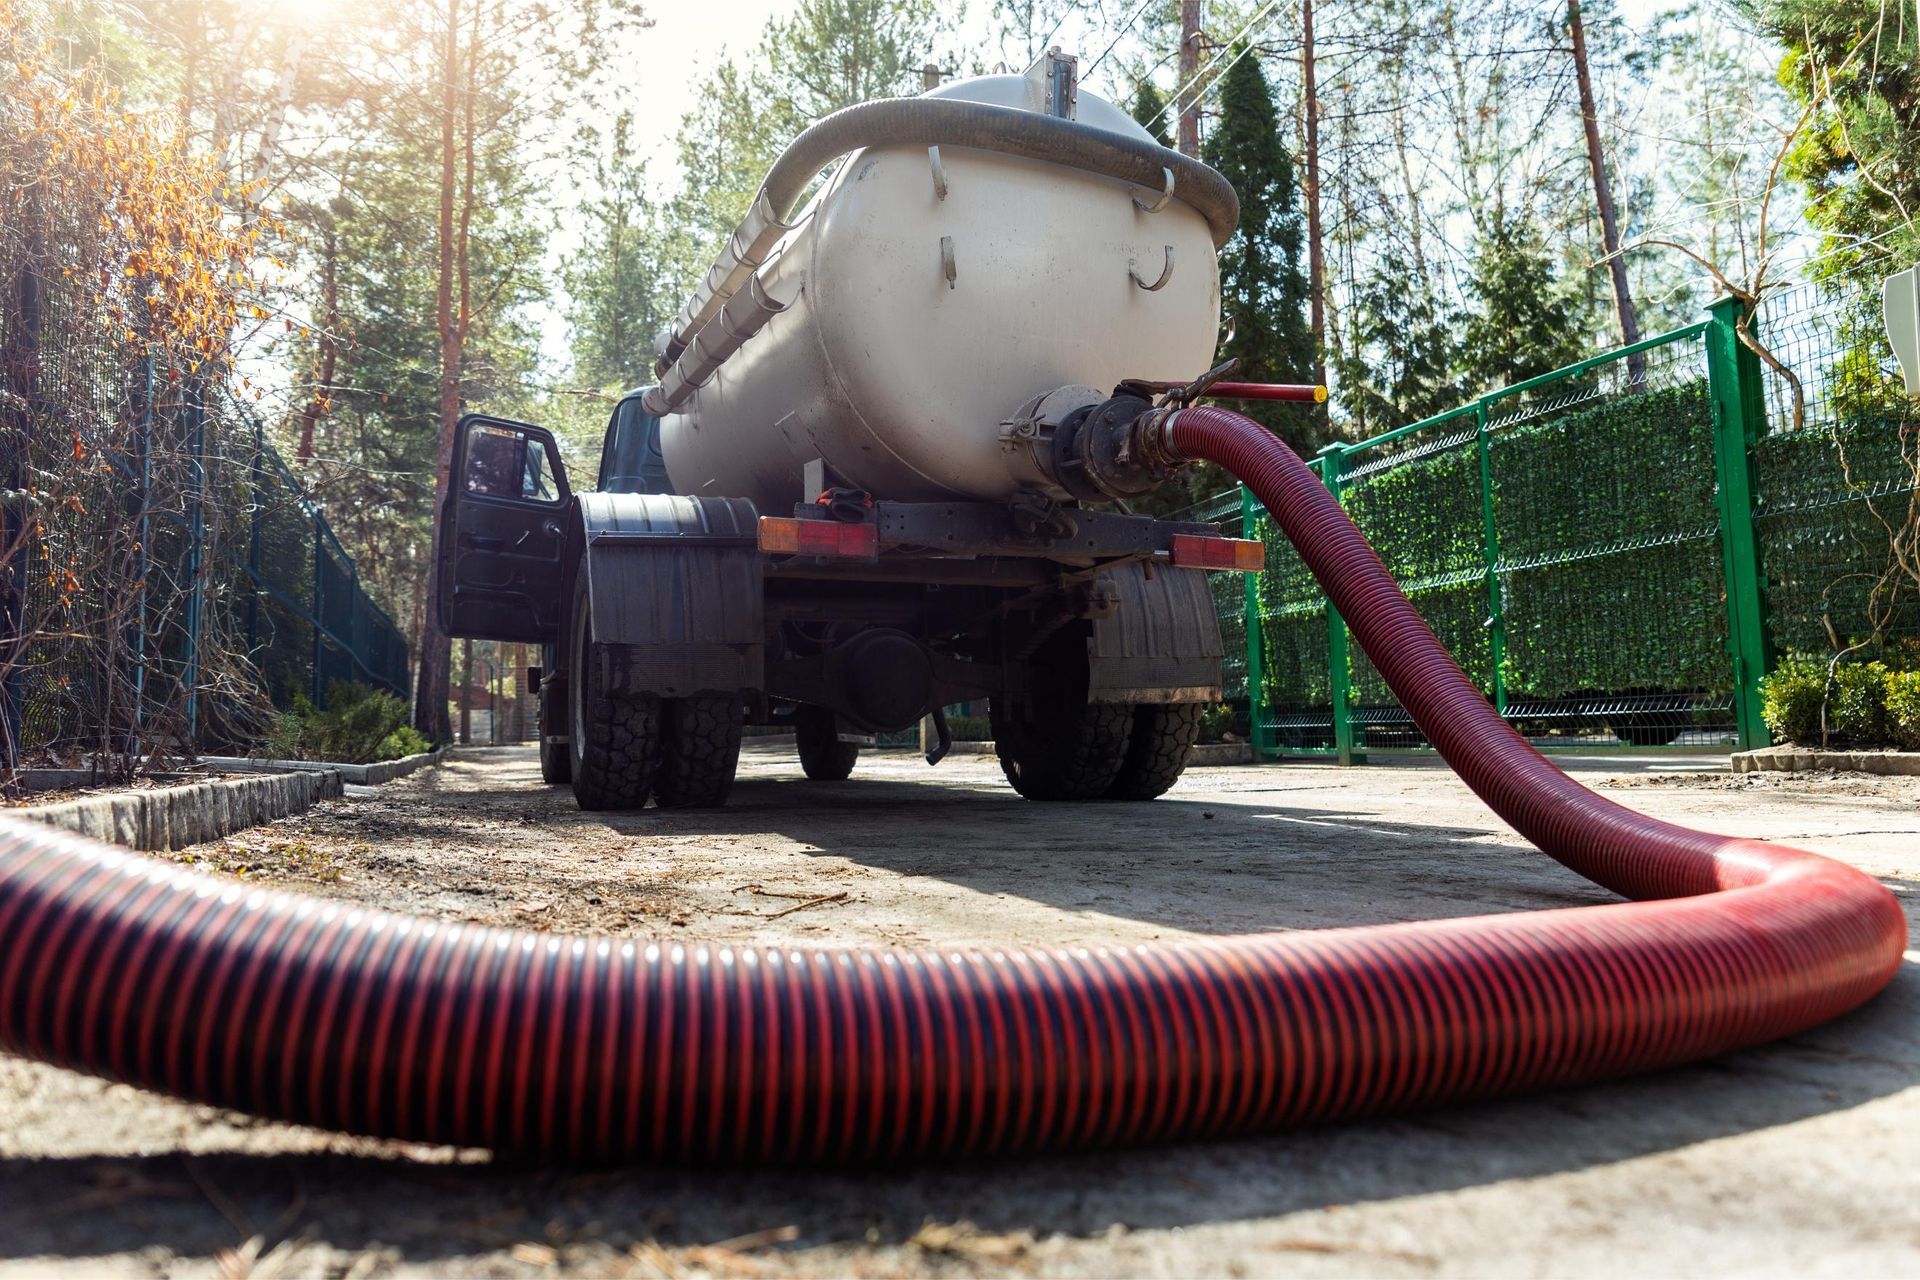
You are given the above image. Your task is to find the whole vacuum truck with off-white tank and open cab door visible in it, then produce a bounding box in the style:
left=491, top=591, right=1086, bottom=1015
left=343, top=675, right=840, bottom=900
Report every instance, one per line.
left=436, top=50, right=1323, bottom=810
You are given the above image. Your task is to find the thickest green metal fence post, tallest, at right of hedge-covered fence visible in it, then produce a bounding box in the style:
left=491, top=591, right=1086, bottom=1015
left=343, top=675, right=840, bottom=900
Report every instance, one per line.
left=1707, top=297, right=1772, bottom=750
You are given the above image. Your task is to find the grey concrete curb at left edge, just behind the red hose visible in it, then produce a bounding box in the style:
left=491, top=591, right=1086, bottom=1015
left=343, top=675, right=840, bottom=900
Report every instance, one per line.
left=8, top=770, right=340, bottom=852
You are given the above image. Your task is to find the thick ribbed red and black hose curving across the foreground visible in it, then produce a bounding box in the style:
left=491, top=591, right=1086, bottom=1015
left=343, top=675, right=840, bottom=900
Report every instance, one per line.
left=0, top=409, right=1907, bottom=1161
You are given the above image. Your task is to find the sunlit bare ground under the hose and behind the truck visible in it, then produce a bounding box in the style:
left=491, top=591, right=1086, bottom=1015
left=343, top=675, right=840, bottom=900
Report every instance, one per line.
left=0, top=748, right=1920, bottom=1276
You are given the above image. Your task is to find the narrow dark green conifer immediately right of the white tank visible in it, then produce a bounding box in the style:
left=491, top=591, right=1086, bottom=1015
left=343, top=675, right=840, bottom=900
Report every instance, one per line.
left=1204, top=48, right=1327, bottom=451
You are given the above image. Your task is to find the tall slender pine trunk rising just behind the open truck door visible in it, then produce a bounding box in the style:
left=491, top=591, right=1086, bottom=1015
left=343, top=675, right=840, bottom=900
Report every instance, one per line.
left=413, top=0, right=463, bottom=743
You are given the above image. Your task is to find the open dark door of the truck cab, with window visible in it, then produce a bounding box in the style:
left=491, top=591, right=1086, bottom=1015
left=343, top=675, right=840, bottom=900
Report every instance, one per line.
left=434, top=415, right=570, bottom=645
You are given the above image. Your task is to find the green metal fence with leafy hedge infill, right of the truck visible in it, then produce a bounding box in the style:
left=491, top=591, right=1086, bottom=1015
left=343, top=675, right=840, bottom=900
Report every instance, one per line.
left=1223, top=280, right=1920, bottom=762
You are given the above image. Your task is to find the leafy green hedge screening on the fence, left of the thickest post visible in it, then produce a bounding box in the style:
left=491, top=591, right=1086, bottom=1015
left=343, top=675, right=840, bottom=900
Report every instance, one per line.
left=1258, top=378, right=1732, bottom=708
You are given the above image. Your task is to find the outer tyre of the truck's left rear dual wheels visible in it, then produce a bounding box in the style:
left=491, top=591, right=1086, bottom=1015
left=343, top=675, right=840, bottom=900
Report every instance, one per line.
left=566, top=574, right=660, bottom=810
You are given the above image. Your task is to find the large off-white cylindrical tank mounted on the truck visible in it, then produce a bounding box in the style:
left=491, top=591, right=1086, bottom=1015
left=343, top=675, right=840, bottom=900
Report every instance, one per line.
left=660, top=66, right=1219, bottom=514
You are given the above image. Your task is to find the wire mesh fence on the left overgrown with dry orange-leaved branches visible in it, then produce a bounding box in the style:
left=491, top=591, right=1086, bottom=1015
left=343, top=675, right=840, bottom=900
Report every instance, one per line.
left=0, top=15, right=407, bottom=781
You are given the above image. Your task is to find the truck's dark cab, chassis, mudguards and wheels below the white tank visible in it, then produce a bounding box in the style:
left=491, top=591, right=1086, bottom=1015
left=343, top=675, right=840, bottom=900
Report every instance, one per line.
left=434, top=390, right=1261, bottom=810
